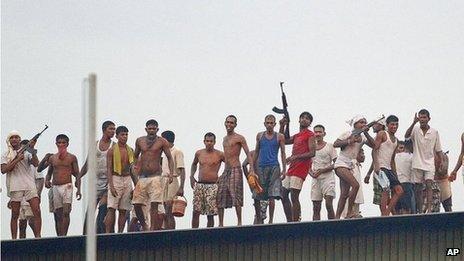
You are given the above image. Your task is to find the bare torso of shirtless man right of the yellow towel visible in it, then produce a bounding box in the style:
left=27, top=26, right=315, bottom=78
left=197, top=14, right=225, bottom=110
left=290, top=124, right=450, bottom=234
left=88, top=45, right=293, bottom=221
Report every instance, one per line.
left=135, top=136, right=169, bottom=175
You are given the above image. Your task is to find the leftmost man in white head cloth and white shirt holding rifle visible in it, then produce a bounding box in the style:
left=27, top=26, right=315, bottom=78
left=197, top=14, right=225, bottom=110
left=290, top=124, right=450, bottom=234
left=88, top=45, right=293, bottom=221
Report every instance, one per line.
left=1, top=131, right=42, bottom=239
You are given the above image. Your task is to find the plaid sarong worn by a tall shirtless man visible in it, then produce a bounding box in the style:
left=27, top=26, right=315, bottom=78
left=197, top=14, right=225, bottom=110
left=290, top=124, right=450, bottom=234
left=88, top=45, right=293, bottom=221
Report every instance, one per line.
left=217, top=167, right=243, bottom=208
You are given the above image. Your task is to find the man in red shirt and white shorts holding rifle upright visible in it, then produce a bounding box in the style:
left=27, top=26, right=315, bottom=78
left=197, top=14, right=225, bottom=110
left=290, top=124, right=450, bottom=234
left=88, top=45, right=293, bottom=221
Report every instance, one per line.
left=279, top=111, right=316, bottom=222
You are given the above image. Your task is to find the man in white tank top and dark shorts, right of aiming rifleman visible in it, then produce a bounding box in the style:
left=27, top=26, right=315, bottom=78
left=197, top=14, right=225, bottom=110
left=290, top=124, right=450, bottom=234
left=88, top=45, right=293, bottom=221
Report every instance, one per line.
left=373, top=115, right=403, bottom=216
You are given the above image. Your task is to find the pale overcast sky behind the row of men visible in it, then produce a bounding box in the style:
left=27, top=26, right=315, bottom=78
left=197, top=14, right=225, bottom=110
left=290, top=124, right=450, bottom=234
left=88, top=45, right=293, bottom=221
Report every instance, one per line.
left=1, top=0, right=464, bottom=239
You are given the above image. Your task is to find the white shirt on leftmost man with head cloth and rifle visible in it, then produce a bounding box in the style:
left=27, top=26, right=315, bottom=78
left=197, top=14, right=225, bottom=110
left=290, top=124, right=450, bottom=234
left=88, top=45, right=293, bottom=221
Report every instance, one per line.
left=1, top=151, right=36, bottom=192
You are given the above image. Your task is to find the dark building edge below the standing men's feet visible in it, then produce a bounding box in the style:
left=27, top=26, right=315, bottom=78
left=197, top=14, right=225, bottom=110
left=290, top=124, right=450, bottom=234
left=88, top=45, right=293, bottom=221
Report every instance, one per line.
left=2, top=212, right=464, bottom=260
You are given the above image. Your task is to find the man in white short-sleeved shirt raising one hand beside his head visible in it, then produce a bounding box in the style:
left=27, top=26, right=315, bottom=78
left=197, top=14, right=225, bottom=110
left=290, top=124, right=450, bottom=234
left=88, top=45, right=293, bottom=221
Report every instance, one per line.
left=404, top=109, right=443, bottom=213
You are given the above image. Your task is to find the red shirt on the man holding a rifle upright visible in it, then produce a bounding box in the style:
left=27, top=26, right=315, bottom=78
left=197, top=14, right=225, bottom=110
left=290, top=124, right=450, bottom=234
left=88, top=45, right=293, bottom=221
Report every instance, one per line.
left=287, top=129, right=314, bottom=180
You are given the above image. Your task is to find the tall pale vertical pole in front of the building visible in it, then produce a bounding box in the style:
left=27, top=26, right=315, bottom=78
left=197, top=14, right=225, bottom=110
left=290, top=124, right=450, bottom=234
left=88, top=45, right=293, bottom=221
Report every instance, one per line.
left=86, top=73, right=97, bottom=261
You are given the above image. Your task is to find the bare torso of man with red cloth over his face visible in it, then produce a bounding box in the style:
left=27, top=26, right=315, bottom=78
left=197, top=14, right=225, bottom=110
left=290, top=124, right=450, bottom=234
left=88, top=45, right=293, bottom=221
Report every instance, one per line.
left=49, top=153, right=79, bottom=185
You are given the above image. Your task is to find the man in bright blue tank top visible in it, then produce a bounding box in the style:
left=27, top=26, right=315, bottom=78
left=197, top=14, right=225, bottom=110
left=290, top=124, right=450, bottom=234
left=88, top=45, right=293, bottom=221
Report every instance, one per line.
left=253, top=115, right=287, bottom=224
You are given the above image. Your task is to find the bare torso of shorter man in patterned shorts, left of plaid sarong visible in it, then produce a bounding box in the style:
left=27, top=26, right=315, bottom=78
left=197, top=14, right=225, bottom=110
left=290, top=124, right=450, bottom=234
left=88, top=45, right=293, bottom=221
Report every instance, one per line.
left=197, top=149, right=224, bottom=183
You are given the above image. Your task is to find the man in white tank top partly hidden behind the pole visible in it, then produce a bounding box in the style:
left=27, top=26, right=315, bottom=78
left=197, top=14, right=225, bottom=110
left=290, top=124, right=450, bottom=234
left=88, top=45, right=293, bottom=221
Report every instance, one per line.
left=76, top=121, right=116, bottom=234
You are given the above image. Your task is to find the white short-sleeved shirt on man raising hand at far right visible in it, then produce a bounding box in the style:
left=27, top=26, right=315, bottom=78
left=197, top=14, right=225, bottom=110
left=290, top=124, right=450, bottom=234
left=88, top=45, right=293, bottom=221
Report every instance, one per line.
left=411, top=126, right=441, bottom=171
